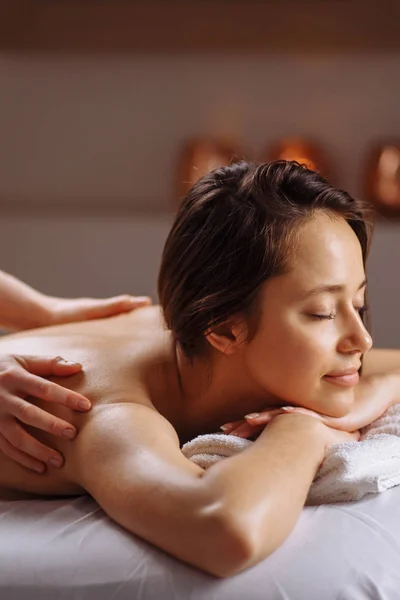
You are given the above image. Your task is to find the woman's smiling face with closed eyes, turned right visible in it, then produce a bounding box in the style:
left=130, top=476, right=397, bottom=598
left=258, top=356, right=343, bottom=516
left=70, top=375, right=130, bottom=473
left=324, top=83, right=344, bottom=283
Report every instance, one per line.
left=244, top=211, right=372, bottom=417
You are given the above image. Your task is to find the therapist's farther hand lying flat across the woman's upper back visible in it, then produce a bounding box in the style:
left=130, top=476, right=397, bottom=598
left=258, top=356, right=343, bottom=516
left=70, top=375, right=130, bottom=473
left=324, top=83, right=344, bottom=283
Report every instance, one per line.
left=43, top=295, right=151, bottom=325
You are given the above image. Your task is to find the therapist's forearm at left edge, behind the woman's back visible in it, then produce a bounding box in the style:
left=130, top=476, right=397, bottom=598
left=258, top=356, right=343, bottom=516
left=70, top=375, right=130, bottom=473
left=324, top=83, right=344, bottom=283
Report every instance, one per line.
left=0, top=271, right=49, bottom=331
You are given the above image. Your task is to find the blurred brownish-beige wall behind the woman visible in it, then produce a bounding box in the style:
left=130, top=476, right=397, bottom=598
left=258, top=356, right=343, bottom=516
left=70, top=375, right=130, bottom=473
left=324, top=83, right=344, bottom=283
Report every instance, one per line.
left=0, top=0, right=400, bottom=346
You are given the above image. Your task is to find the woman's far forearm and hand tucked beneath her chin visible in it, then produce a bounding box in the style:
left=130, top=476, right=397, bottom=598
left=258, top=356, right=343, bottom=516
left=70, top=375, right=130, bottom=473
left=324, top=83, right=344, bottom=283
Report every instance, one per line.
left=222, top=373, right=400, bottom=438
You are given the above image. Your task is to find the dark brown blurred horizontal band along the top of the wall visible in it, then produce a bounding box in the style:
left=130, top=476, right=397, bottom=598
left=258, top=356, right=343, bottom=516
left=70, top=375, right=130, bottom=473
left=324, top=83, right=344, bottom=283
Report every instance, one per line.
left=0, top=0, right=400, bottom=53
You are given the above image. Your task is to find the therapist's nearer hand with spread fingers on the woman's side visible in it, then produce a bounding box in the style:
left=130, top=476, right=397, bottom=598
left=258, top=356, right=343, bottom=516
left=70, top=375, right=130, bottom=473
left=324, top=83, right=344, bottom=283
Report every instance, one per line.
left=0, top=355, right=91, bottom=473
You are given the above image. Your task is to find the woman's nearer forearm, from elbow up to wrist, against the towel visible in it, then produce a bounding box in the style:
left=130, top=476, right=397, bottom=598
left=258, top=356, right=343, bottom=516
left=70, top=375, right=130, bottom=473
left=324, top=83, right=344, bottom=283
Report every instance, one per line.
left=203, top=415, right=325, bottom=570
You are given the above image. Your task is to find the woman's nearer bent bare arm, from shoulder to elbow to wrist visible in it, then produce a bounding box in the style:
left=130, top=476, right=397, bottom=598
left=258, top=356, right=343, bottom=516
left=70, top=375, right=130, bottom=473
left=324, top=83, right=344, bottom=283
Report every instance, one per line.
left=72, top=403, right=357, bottom=577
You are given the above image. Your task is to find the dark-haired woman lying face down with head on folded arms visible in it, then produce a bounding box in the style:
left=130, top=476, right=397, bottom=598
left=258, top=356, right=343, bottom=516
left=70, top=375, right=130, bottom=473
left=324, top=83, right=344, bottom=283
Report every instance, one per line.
left=0, top=161, right=400, bottom=577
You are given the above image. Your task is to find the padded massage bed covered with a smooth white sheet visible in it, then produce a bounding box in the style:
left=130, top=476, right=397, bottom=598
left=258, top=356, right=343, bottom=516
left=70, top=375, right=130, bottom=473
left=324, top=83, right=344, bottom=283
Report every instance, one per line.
left=0, top=486, right=400, bottom=600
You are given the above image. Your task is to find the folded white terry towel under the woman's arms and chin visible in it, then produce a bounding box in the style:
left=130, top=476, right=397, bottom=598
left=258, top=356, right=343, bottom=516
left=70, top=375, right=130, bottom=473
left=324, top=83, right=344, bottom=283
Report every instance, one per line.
left=182, top=404, right=400, bottom=505
